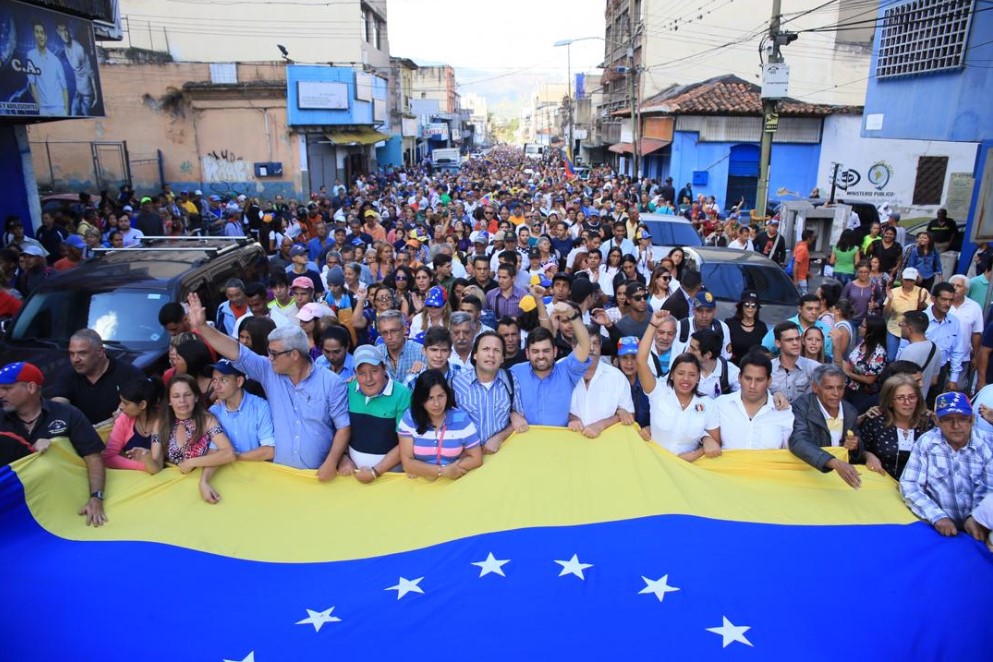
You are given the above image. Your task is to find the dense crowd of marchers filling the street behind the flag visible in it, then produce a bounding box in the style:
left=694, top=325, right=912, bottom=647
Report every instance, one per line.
left=0, top=148, right=993, bottom=544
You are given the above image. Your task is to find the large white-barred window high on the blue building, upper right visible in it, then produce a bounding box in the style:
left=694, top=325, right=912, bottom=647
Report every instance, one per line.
left=876, top=0, right=976, bottom=78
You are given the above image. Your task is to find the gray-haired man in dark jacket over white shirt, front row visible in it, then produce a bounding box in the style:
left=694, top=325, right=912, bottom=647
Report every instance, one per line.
left=790, top=364, right=862, bottom=489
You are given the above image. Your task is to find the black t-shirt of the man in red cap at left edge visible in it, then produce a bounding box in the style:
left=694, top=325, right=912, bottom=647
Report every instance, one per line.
left=0, top=400, right=104, bottom=467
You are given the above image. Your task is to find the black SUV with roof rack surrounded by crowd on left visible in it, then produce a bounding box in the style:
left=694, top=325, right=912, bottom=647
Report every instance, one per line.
left=0, top=237, right=265, bottom=376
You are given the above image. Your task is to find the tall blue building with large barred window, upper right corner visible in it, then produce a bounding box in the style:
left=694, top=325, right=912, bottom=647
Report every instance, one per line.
left=862, top=0, right=993, bottom=272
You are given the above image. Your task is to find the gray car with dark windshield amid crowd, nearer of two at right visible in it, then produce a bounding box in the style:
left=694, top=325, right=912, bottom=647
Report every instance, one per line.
left=686, top=247, right=800, bottom=327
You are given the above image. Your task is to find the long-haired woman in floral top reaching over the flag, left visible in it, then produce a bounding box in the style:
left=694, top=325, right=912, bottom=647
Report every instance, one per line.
left=152, top=375, right=235, bottom=503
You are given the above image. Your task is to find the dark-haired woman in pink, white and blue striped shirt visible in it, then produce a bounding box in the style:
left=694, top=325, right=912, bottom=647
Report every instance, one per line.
left=397, top=370, right=483, bottom=480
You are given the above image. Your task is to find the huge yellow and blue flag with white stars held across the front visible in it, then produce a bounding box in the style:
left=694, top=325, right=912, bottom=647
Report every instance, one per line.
left=0, top=427, right=993, bottom=662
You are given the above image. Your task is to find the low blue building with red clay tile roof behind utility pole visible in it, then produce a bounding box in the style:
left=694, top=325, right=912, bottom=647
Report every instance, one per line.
left=636, top=75, right=861, bottom=214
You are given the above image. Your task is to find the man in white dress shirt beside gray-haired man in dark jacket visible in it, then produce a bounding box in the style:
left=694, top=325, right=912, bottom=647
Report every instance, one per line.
left=717, top=352, right=793, bottom=450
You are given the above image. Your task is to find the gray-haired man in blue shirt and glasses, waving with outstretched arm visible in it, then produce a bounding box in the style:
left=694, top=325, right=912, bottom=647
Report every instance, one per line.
left=189, top=293, right=351, bottom=480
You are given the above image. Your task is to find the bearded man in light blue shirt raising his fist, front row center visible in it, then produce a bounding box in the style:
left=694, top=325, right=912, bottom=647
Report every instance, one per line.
left=510, top=302, right=590, bottom=427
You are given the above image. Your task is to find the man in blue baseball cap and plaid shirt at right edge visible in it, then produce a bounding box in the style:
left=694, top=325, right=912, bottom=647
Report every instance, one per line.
left=900, top=391, right=993, bottom=540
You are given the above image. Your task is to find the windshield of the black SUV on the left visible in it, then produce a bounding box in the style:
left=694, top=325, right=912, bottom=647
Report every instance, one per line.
left=11, top=289, right=169, bottom=350
